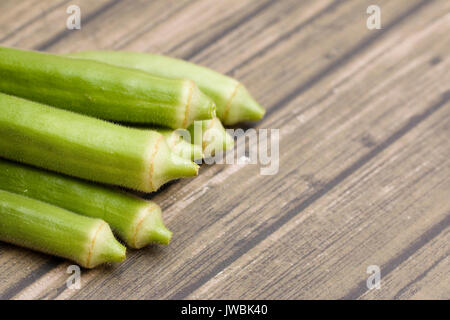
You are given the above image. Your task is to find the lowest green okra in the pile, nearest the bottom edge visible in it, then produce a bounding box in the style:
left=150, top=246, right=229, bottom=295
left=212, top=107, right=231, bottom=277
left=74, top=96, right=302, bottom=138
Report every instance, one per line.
left=0, top=190, right=125, bottom=268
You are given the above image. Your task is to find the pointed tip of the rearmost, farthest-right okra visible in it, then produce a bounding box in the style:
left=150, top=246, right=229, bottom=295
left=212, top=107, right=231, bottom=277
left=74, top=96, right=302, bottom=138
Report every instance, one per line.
left=222, top=85, right=266, bottom=125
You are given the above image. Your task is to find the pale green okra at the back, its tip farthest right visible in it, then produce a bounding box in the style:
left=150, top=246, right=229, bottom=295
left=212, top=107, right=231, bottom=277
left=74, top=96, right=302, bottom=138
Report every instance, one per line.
left=71, top=51, right=265, bottom=125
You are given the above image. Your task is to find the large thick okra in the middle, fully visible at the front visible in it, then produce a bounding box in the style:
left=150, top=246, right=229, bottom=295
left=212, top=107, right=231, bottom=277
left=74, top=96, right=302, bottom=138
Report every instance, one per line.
left=0, top=94, right=198, bottom=192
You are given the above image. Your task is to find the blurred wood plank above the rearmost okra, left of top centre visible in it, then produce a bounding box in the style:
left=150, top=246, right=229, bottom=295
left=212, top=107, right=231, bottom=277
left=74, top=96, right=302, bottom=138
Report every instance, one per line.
left=40, top=0, right=278, bottom=54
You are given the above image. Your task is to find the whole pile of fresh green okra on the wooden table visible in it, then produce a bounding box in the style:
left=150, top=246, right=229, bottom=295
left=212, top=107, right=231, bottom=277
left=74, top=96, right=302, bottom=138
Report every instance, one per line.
left=0, top=47, right=264, bottom=268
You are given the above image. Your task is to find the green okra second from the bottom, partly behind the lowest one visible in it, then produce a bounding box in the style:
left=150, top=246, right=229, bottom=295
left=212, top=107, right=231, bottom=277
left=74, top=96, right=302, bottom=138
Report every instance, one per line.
left=0, top=159, right=172, bottom=249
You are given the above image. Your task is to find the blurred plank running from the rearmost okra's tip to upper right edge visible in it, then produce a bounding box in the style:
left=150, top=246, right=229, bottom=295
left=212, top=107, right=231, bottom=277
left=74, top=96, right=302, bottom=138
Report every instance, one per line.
left=193, top=1, right=428, bottom=106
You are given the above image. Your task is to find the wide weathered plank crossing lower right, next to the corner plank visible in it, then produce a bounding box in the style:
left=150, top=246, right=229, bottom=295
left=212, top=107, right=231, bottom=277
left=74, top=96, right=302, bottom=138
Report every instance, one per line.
left=189, top=103, right=450, bottom=299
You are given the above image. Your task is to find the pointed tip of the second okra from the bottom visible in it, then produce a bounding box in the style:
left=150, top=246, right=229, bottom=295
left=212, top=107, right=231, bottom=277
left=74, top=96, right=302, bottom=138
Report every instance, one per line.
left=133, top=204, right=172, bottom=249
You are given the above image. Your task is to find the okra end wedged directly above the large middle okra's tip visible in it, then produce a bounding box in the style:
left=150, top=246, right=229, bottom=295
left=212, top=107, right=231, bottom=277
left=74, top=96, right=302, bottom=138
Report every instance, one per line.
left=152, top=127, right=204, bottom=161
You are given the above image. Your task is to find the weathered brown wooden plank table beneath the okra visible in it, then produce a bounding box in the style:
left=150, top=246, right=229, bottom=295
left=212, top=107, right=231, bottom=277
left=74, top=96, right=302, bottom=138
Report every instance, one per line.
left=0, top=0, right=450, bottom=299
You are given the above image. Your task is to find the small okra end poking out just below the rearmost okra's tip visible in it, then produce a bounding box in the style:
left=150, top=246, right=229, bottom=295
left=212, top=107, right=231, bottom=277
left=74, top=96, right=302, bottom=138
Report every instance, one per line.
left=188, top=118, right=234, bottom=157
